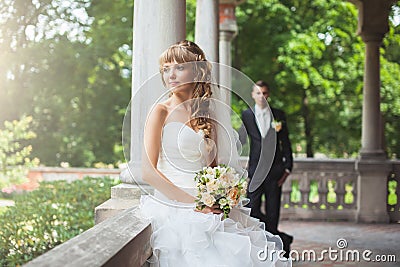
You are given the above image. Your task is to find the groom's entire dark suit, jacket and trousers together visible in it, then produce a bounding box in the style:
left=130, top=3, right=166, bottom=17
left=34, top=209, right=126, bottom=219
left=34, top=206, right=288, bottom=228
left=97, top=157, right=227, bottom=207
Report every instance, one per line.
left=239, top=109, right=293, bottom=253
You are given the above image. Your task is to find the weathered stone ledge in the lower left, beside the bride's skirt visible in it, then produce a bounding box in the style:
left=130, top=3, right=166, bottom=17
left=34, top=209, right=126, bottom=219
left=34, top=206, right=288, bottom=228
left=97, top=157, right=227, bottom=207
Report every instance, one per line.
left=24, top=207, right=151, bottom=267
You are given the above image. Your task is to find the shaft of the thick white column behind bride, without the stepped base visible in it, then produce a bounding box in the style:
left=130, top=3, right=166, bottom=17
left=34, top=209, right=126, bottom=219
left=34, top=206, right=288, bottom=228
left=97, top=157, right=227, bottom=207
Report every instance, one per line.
left=121, top=0, right=186, bottom=183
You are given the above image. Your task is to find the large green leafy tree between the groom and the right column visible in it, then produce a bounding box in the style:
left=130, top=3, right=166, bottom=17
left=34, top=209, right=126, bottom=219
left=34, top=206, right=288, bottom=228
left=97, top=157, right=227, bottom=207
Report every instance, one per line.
left=275, top=1, right=363, bottom=157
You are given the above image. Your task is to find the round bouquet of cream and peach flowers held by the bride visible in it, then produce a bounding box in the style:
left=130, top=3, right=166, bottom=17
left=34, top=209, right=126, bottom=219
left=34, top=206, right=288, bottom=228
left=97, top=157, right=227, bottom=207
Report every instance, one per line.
left=194, top=164, right=247, bottom=218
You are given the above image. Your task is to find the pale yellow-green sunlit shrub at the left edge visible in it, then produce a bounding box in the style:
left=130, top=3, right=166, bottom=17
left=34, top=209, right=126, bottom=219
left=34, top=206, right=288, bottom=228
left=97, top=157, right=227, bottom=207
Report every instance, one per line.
left=0, top=116, right=39, bottom=189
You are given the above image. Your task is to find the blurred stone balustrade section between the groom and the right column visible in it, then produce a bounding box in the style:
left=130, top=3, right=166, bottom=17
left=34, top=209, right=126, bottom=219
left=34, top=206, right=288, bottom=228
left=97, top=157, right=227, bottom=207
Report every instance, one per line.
left=281, top=159, right=358, bottom=221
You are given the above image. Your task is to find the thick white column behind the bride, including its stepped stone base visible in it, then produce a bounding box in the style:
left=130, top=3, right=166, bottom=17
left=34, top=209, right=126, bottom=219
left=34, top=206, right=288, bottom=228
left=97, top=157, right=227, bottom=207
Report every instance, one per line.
left=99, top=0, right=186, bottom=223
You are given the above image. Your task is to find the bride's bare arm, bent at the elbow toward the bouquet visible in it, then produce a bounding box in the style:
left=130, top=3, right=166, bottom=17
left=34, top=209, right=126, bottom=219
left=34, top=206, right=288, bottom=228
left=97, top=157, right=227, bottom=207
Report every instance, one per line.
left=142, top=104, right=194, bottom=203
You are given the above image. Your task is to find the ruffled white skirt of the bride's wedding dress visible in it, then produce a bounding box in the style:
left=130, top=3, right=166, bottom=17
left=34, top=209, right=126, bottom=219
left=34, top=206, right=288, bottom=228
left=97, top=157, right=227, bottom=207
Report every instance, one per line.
left=140, top=195, right=291, bottom=267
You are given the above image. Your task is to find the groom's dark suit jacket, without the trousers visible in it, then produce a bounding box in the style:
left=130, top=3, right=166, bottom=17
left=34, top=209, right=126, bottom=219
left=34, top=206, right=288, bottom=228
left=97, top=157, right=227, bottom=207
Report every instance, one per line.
left=239, top=108, right=293, bottom=184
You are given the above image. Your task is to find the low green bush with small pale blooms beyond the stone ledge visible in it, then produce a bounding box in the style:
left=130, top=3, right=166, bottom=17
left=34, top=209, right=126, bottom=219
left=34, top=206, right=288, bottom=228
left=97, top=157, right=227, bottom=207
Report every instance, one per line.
left=0, top=177, right=118, bottom=266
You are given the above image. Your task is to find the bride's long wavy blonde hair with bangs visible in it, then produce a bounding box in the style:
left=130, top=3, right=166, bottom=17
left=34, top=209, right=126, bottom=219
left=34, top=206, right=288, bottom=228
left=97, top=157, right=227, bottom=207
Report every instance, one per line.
left=160, top=40, right=213, bottom=138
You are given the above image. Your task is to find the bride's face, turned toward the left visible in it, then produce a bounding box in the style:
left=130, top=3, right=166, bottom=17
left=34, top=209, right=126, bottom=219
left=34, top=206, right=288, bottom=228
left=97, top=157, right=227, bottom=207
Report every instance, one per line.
left=163, top=62, right=194, bottom=92
